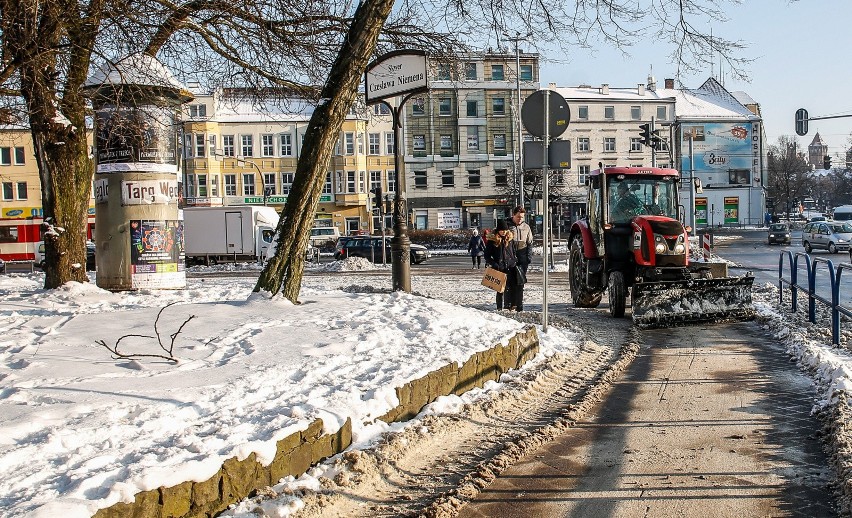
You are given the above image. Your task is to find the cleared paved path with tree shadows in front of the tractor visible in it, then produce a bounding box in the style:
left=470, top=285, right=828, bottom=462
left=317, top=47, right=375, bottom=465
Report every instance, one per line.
left=459, top=323, right=836, bottom=518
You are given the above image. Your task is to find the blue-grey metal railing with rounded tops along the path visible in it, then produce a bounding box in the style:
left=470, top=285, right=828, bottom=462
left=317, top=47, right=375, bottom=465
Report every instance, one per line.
left=778, top=251, right=852, bottom=345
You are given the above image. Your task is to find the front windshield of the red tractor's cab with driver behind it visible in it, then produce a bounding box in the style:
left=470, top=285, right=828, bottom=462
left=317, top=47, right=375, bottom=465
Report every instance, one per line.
left=608, top=175, right=678, bottom=223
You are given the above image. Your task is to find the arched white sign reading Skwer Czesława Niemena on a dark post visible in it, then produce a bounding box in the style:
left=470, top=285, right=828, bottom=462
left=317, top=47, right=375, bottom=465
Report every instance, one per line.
left=364, top=50, right=429, bottom=104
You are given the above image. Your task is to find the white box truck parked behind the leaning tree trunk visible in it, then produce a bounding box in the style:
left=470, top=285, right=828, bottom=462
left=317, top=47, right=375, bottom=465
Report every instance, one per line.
left=183, top=207, right=278, bottom=266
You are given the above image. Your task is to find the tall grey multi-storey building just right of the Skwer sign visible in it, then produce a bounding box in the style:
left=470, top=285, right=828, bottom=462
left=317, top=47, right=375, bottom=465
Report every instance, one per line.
left=404, top=51, right=539, bottom=229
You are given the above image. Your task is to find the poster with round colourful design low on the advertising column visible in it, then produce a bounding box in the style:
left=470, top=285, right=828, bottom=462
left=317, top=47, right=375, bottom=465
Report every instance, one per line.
left=130, top=219, right=186, bottom=289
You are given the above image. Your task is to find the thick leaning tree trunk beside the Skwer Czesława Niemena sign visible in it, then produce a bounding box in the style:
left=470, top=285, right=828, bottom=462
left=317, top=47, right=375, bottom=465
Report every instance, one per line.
left=254, top=0, right=393, bottom=303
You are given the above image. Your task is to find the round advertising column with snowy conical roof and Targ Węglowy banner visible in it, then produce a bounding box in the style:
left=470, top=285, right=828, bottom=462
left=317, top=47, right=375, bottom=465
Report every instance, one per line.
left=86, top=55, right=192, bottom=291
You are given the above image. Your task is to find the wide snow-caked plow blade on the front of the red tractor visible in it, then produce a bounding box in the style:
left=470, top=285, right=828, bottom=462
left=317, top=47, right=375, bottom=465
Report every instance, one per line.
left=633, top=273, right=754, bottom=329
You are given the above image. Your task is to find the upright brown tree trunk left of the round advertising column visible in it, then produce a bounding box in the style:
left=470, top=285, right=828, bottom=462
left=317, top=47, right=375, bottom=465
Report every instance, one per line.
left=4, top=1, right=94, bottom=288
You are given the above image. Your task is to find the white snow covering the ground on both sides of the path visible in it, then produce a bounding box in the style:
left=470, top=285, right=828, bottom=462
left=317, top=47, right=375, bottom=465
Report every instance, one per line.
left=0, top=245, right=852, bottom=518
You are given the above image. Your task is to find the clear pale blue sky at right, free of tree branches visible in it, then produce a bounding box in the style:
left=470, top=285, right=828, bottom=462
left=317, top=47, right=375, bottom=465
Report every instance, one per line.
left=541, top=0, right=852, bottom=162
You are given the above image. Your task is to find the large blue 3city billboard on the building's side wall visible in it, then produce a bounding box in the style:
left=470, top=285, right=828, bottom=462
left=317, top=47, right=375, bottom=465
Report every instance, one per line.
left=680, top=122, right=760, bottom=181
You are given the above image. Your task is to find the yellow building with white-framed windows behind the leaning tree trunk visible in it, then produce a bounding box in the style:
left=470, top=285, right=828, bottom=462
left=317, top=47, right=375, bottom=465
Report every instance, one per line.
left=183, top=87, right=396, bottom=234
